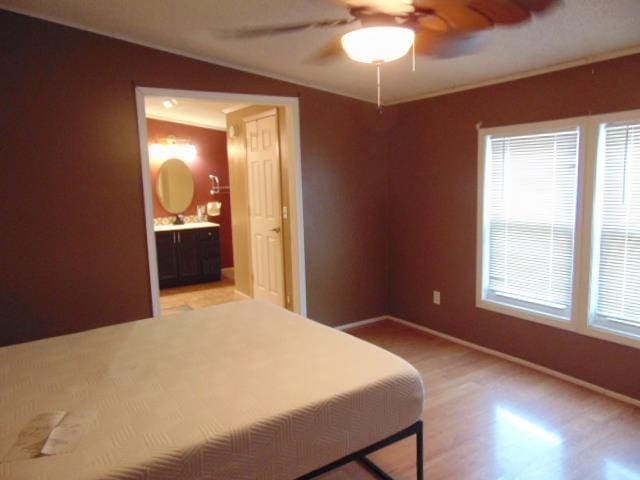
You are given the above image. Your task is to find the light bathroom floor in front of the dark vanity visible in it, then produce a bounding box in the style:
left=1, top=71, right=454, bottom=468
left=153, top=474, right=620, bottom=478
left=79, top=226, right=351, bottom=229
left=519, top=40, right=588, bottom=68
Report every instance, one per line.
left=160, top=278, right=245, bottom=315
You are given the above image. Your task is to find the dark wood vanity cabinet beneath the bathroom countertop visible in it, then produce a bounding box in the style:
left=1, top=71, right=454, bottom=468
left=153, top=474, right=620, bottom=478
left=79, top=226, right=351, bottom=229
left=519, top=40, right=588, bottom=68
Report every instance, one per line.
left=156, top=227, right=220, bottom=288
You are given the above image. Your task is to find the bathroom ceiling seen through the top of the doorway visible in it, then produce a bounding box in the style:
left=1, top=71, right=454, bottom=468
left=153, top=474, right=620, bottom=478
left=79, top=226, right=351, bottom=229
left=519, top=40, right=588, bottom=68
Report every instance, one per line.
left=144, top=97, right=248, bottom=130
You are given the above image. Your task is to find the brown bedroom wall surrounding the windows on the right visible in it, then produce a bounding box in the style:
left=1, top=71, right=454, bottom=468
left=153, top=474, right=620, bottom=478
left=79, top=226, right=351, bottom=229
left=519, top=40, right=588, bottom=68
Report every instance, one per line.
left=389, top=55, right=640, bottom=398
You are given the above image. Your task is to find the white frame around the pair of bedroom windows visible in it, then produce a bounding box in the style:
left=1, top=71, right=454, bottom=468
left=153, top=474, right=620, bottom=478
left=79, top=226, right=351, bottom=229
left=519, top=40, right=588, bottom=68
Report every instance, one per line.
left=476, top=110, right=640, bottom=348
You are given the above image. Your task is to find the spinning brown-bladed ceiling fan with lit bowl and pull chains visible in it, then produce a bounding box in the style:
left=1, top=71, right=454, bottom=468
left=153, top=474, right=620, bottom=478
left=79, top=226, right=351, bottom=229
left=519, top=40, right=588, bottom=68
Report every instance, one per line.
left=219, top=0, right=562, bottom=106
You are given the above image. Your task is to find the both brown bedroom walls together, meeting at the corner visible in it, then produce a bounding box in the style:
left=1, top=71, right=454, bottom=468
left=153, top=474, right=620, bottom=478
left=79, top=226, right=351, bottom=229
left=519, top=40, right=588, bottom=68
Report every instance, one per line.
left=0, top=12, right=640, bottom=404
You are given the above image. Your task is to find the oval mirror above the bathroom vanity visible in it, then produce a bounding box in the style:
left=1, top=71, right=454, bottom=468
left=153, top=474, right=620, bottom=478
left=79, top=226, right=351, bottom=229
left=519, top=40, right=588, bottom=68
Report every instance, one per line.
left=156, top=158, right=194, bottom=214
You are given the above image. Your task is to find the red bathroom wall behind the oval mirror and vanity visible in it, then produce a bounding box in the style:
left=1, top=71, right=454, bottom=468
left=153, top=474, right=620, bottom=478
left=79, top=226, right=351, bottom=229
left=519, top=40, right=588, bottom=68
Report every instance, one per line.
left=147, top=118, right=233, bottom=268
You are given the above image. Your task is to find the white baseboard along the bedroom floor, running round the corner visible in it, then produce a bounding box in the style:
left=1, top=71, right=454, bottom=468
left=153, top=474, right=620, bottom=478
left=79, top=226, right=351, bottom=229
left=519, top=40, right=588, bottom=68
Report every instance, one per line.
left=336, top=315, right=640, bottom=407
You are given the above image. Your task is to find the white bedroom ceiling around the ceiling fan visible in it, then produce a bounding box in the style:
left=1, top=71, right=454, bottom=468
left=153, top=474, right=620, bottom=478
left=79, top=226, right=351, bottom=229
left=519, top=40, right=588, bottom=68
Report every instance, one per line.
left=0, top=0, right=640, bottom=103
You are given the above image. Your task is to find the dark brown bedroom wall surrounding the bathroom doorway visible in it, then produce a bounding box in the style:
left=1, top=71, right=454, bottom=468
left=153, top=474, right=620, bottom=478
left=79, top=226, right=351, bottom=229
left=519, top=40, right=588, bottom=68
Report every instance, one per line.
left=0, top=11, right=387, bottom=344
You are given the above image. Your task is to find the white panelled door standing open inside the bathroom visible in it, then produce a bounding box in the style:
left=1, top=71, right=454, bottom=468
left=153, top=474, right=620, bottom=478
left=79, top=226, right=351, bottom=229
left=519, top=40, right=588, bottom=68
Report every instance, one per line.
left=245, top=112, right=285, bottom=306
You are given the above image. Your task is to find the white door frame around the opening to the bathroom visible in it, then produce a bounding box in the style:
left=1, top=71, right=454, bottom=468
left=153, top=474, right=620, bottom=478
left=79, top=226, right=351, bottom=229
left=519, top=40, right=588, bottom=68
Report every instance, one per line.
left=135, top=87, right=307, bottom=317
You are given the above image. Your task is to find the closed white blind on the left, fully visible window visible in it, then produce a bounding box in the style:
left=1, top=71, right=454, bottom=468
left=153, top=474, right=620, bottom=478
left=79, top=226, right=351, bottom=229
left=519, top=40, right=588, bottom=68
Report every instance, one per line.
left=483, top=126, right=580, bottom=319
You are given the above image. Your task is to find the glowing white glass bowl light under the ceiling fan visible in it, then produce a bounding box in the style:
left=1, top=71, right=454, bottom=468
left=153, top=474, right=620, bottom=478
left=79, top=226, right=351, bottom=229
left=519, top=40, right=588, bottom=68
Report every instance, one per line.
left=342, top=27, right=415, bottom=63
